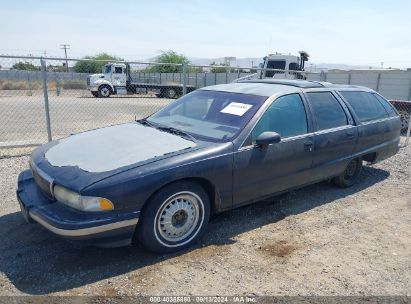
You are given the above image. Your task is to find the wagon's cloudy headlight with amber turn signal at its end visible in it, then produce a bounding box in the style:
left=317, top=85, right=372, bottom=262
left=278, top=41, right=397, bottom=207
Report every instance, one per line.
left=53, top=185, right=114, bottom=211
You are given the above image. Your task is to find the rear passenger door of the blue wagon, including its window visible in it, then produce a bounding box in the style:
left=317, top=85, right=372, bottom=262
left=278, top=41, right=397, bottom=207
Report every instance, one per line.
left=306, top=91, right=358, bottom=182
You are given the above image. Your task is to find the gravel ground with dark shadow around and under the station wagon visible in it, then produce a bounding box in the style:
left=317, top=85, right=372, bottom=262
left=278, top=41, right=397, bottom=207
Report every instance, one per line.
left=0, top=141, right=411, bottom=296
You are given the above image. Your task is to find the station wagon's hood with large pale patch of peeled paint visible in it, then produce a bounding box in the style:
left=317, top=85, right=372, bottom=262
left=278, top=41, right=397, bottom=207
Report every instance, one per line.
left=32, top=123, right=198, bottom=191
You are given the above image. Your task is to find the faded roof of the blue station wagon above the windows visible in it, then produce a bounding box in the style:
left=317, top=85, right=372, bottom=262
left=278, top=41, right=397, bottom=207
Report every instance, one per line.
left=200, top=79, right=370, bottom=97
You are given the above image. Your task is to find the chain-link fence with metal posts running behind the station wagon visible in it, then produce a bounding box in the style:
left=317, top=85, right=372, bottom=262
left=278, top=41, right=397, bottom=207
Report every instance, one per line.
left=0, top=55, right=411, bottom=157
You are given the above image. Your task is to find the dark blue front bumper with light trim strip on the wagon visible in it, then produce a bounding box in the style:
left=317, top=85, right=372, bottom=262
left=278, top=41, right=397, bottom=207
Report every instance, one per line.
left=17, top=170, right=140, bottom=247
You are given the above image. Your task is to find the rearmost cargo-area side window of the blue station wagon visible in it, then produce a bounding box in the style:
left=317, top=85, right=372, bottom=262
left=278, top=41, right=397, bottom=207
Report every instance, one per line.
left=340, top=91, right=388, bottom=122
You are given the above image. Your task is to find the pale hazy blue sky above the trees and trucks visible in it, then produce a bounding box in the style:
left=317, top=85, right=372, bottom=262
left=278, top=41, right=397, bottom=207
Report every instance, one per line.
left=0, top=0, right=411, bottom=68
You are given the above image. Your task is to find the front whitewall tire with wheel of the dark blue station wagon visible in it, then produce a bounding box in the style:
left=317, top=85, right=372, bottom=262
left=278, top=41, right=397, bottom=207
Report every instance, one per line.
left=136, top=182, right=210, bottom=253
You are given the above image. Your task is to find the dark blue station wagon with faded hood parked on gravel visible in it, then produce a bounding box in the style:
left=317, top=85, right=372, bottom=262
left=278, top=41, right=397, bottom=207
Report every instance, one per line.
left=17, top=79, right=401, bottom=252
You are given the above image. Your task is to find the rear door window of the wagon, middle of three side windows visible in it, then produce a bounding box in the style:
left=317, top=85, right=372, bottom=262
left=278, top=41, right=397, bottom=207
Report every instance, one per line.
left=307, top=92, right=348, bottom=130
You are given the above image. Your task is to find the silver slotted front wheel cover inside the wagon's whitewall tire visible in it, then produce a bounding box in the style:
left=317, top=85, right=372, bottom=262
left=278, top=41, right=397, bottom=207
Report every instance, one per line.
left=157, top=193, right=200, bottom=242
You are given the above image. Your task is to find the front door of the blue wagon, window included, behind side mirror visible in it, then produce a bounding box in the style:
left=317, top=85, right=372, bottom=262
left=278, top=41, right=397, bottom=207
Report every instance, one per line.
left=233, top=94, right=314, bottom=205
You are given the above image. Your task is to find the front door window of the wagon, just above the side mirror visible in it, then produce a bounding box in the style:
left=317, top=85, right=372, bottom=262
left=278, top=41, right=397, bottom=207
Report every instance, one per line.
left=252, top=94, right=307, bottom=143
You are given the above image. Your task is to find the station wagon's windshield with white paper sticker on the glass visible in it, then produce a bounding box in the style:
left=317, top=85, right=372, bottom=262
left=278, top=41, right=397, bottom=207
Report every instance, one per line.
left=147, top=90, right=267, bottom=141
